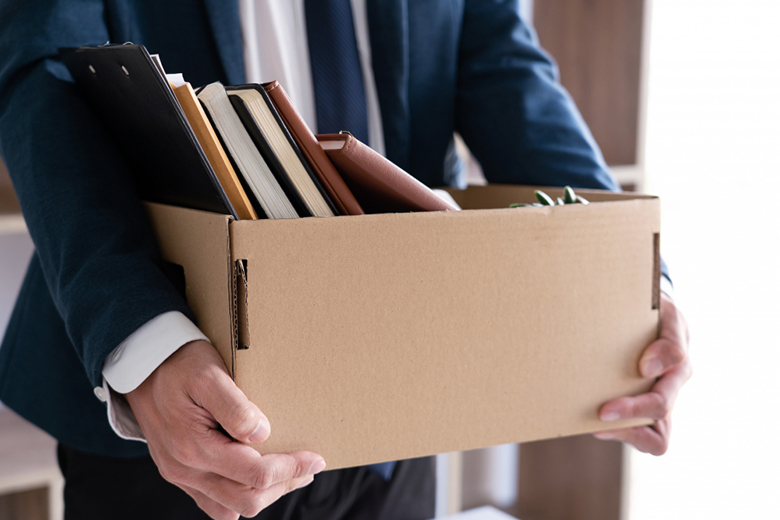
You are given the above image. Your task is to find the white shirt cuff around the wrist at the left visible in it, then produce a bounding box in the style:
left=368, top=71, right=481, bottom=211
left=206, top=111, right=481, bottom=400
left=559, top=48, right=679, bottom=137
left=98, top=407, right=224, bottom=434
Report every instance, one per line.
left=95, top=311, right=209, bottom=441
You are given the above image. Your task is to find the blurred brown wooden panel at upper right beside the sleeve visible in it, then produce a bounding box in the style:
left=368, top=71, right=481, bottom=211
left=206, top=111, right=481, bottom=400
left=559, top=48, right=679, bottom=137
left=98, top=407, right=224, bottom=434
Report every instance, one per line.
left=534, top=0, right=644, bottom=166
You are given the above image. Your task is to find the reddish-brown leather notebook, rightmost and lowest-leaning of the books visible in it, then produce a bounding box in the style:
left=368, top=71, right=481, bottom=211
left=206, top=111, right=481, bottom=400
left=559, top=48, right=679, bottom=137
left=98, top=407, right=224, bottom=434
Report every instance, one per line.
left=317, top=134, right=458, bottom=213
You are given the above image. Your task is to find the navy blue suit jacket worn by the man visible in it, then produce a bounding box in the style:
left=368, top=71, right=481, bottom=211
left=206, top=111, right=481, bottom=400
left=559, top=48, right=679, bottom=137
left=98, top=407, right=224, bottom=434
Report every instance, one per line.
left=0, top=0, right=617, bottom=456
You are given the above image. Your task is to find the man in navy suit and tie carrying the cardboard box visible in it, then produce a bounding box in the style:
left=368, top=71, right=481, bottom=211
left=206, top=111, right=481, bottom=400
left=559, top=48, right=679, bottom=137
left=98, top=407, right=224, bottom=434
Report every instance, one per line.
left=0, top=0, right=690, bottom=519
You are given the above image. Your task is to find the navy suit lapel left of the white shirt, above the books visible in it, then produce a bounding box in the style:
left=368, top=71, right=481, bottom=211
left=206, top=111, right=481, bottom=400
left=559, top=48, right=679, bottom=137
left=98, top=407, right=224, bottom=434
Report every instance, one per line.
left=203, top=0, right=246, bottom=85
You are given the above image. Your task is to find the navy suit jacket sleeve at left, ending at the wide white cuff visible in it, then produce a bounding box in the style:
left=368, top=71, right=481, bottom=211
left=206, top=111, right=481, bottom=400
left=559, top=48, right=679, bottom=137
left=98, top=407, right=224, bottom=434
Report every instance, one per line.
left=0, top=0, right=191, bottom=387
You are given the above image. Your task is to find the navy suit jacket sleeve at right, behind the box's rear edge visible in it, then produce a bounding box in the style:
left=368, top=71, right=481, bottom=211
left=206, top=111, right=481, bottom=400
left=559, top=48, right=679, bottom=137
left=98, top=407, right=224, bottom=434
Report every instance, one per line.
left=455, top=0, right=619, bottom=190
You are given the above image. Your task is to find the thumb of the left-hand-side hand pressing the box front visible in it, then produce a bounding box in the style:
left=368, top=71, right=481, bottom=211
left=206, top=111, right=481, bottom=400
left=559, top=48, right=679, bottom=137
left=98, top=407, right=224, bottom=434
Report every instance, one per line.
left=199, top=370, right=271, bottom=444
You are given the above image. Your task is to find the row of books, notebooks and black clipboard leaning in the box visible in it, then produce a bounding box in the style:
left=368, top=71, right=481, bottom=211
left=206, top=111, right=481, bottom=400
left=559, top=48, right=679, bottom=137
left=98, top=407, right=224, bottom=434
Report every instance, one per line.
left=60, top=44, right=457, bottom=219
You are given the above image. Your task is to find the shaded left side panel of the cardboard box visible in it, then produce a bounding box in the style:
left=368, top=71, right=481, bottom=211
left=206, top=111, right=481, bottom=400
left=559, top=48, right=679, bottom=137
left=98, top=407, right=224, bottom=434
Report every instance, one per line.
left=146, top=202, right=233, bottom=369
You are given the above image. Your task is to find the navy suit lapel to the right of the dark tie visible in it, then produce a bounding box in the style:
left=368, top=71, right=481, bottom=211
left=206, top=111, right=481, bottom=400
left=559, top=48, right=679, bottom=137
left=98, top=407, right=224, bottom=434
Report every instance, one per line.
left=366, top=0, right=410, bottom=169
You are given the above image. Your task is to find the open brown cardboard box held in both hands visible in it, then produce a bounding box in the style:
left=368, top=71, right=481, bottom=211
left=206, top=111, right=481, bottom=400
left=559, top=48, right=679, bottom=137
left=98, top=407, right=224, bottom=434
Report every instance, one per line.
left=149, top=185, right=660, bottom=469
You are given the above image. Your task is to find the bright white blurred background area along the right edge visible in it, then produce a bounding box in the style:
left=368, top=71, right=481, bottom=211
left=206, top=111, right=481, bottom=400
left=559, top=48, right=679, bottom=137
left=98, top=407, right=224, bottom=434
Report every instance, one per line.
left=628, top=0, right=780, bottom=520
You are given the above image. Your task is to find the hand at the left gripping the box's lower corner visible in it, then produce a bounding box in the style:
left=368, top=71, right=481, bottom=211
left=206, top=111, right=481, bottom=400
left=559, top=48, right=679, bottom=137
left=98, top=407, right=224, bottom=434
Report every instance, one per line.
left=126, top=341, right=325, bottom=520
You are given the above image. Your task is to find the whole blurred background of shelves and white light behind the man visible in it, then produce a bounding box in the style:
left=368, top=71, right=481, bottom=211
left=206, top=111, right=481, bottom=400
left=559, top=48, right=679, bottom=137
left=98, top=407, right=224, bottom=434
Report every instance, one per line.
left=0, top=0, right=780, bottom=520
